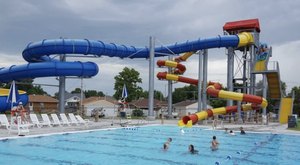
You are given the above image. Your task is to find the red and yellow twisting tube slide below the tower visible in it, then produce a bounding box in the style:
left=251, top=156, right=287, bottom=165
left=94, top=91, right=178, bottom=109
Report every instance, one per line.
left=157, top=33, right=268, bottom=127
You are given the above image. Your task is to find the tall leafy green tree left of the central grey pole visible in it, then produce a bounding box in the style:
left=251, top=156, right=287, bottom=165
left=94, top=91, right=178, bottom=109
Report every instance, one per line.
left=113, top=67, right=143, bottom=102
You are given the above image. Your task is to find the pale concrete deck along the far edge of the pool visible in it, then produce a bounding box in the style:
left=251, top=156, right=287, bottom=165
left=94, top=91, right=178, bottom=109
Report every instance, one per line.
left=0, top=119, right=300, bottom=139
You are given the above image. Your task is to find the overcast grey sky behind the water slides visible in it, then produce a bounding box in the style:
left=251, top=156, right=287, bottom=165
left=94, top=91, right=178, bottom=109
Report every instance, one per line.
left=0, top=0, right=300, bottom=95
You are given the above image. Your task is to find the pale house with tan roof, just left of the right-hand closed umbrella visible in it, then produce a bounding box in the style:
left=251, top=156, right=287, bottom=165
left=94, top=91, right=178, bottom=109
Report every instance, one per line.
left=82, top=96, right=118, bottom=117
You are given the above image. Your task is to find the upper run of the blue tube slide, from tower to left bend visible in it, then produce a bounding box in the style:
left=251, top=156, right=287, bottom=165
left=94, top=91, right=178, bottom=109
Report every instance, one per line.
left=22, top=35, right=239, bottom=62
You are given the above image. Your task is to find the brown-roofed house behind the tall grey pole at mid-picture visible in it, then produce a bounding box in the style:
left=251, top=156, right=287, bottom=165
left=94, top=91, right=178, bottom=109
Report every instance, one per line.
left=129, top=98, right=168, bottom=117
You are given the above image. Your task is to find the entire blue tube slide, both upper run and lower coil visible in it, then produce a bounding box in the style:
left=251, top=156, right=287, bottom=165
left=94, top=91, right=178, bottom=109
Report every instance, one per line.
left=0, top=35, right=239, bottom=111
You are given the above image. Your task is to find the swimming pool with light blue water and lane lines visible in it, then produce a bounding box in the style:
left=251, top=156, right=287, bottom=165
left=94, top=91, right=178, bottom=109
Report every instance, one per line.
left=0, top=126, right=300, bottom=165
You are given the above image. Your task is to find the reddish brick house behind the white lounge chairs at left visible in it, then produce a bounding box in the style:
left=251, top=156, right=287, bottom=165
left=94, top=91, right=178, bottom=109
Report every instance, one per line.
left=25, top=95, right=58, bottom=113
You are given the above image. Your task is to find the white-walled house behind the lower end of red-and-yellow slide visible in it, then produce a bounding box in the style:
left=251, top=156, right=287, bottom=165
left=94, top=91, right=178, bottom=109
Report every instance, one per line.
left=173, top=100, right=212, bottom=118
